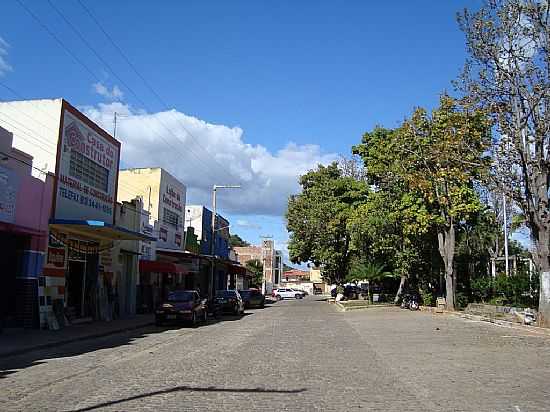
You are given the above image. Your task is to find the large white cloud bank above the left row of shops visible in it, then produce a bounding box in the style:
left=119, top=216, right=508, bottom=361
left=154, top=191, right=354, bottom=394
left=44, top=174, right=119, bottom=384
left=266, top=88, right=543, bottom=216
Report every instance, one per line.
left=83, top=102, right=337, bottom=216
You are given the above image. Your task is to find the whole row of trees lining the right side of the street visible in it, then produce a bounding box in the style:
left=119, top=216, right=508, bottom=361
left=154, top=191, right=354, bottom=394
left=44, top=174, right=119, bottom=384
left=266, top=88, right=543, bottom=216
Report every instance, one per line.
left=287, top=0, right=550, bottom=326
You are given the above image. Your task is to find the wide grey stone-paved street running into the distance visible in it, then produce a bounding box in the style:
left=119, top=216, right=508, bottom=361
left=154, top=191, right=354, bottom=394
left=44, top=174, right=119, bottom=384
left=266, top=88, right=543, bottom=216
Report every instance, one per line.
left=0, top=297, right=550, bottom=412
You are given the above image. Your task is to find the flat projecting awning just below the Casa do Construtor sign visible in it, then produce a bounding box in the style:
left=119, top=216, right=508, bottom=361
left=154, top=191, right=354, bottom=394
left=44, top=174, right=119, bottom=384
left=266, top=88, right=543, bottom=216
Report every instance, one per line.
left=50, top=219, right=156, bottom=241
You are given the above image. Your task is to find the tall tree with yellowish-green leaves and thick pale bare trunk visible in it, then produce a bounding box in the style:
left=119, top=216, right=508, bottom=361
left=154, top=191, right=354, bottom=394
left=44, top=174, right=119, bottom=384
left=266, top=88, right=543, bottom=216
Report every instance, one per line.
left=354, top=95, right=490, bottom=310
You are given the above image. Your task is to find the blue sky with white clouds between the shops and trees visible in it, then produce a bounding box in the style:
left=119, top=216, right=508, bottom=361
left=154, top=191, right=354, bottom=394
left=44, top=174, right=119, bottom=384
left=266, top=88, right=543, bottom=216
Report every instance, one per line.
left=0, top=0, right=480, bottom=262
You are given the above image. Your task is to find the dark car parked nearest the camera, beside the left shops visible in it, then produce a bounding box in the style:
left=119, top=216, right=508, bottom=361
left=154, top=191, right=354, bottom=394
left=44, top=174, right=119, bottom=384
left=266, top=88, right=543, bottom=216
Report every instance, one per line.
left=155, top=290, right=208, bottom=326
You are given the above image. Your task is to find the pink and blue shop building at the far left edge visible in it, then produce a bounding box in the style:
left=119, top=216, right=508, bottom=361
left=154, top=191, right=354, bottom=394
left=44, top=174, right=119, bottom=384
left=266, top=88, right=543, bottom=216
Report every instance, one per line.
left=0, top=127, right=54, bottom=329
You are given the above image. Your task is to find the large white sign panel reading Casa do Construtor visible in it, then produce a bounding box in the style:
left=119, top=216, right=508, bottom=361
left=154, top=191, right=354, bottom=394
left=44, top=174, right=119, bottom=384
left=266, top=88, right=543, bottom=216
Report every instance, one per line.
left=54, top=104, right=120, bottom=224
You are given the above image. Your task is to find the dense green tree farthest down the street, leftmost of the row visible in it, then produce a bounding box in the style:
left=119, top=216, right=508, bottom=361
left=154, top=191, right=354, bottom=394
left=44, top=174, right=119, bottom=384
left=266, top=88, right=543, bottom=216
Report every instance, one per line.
left=286, top=163, right=369, bottom=284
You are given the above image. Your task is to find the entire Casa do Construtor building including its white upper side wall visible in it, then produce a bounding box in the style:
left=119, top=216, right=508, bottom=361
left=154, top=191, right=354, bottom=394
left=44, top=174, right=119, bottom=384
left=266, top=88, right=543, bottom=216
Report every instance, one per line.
left=0, top=99, right=151, bottom=329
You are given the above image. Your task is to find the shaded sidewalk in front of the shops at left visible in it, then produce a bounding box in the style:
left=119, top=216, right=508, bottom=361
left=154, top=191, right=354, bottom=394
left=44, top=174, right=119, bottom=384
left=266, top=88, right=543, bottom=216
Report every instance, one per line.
left=0, top=314, right=154, bottom=358
